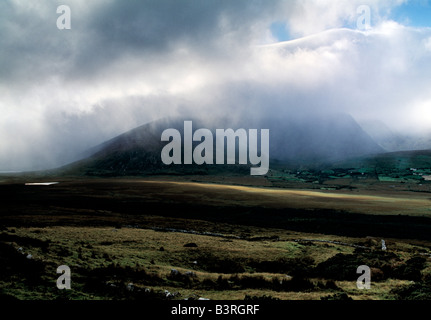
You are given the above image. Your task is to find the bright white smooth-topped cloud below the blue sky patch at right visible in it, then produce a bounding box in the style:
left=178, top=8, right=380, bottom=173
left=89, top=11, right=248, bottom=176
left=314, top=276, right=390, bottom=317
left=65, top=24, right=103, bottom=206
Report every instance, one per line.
left=251, top=22, right=431, bottom=130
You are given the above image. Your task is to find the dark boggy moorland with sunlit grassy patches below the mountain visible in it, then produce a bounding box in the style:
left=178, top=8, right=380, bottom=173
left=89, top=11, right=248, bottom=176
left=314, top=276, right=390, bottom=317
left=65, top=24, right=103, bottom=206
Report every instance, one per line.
left=0, top=177, right=431, bottom=300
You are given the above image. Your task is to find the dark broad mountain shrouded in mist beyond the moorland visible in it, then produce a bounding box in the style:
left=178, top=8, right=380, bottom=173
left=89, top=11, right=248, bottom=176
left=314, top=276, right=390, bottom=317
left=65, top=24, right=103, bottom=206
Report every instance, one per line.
left=62, top=114, right=384, bottom=176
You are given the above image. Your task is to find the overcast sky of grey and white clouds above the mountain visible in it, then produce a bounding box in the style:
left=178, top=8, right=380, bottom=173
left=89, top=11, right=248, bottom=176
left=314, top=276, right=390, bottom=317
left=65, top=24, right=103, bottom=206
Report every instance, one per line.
left=0, top=0, right=431, bottom=171
